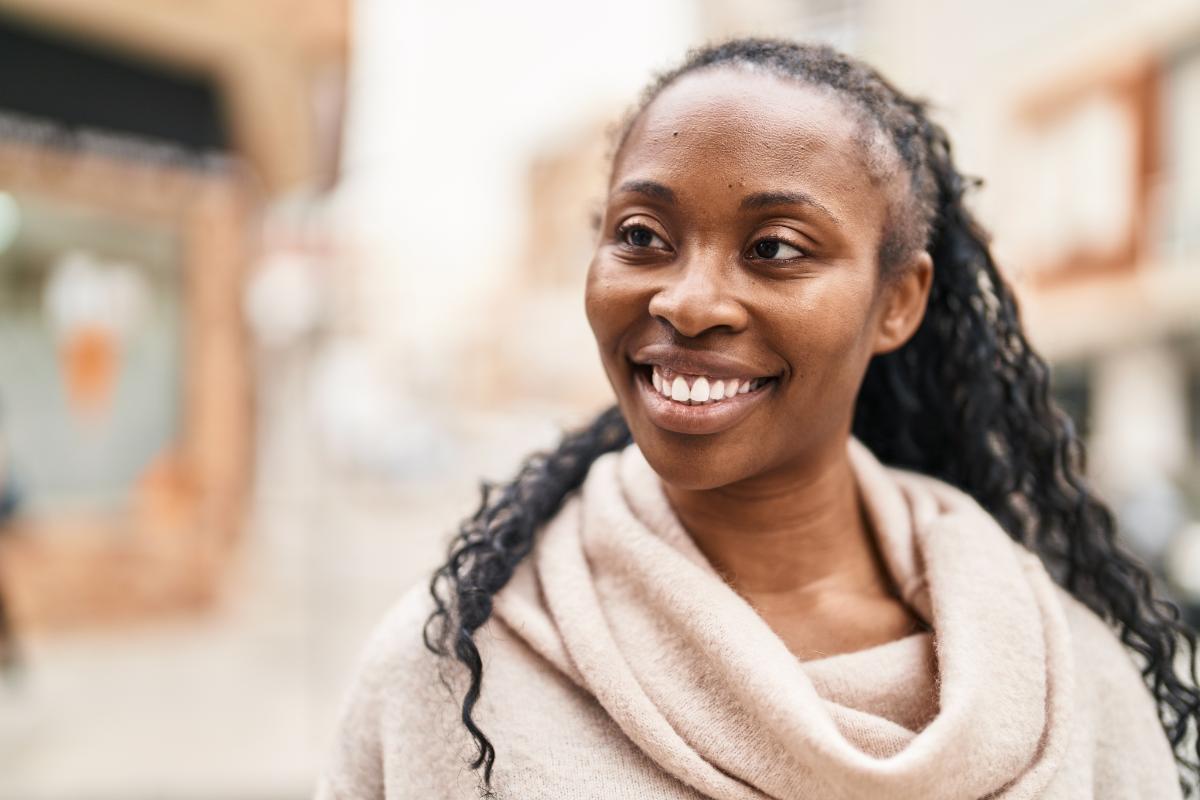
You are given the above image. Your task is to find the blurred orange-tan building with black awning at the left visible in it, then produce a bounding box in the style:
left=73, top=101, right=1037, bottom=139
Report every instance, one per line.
left=0, top=0, right=348, bottom=627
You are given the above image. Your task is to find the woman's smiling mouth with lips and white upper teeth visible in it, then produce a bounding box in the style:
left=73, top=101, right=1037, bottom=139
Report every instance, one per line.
left=631, top=362, right=779, bottom=434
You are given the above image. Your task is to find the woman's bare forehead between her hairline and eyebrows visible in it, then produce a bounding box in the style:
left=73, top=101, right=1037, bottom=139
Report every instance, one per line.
left=612, top=67, right=886, bottom=215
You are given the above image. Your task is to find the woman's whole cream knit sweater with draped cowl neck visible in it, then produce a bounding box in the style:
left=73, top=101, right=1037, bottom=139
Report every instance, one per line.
left=317, top=440, right=1180, bottom=800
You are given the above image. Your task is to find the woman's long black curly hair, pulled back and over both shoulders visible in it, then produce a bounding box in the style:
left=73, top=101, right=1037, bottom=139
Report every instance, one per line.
left=425, top=38, right=1200, bottom=796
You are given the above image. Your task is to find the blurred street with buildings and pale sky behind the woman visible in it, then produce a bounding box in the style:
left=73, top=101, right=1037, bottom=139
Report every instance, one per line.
left=0, top=0, right=1200, bottom=800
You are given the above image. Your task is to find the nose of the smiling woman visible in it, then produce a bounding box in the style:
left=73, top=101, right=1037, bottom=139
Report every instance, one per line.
left=649, top=250, right=746, bottom=338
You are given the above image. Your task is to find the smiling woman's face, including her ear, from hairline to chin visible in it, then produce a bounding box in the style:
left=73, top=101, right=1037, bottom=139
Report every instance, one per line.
left=586, top=68, right=928, bottom=489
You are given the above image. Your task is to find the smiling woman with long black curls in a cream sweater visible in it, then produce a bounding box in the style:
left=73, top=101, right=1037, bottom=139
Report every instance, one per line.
left=323, top=40, right=1200, bottom=800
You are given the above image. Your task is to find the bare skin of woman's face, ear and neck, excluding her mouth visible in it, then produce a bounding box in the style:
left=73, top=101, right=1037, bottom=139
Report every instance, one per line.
left=586, top=67, right=932, bottom=660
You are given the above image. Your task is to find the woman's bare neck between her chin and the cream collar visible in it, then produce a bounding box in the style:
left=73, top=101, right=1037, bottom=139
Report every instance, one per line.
left=664, top=443, right=890, bottom=602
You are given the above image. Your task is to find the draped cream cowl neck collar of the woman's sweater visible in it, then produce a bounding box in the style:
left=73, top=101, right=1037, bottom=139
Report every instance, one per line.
left=496, top=439, right=1073, bottom=800
